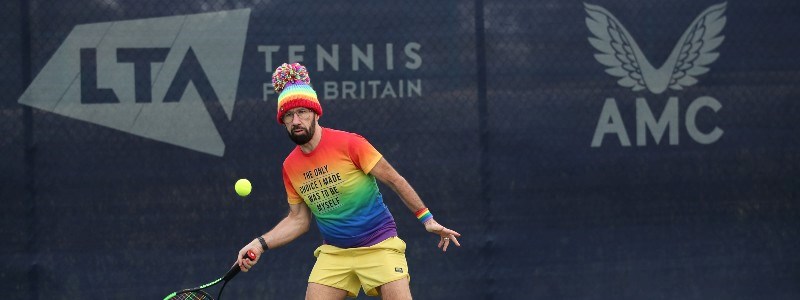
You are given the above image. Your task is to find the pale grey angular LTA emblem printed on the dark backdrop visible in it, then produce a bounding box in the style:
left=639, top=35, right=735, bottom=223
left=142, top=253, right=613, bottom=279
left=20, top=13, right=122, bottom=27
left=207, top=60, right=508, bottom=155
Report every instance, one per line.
left=19, top=9, right=250, bottom=156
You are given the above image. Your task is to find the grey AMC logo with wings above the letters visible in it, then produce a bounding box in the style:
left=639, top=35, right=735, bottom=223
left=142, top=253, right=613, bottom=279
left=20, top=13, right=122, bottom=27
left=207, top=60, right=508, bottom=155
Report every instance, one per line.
left=584, top=2, right=727, bottom=147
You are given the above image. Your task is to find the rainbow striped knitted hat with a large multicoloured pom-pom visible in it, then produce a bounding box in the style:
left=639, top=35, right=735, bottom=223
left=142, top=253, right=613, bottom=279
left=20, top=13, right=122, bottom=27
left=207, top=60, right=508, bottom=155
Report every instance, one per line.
left=272, top=63, right=322, bottom=124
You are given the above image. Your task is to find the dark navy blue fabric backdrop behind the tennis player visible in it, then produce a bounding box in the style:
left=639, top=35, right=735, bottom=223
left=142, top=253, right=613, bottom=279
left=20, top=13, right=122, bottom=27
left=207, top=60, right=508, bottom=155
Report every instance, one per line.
left=0, top=0, right=800, bottom=299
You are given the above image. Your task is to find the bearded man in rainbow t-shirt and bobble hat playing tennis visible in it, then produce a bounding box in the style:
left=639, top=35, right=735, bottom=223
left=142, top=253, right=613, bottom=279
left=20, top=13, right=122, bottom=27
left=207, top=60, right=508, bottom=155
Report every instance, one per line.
left=237, top=63, right=461, bottom=299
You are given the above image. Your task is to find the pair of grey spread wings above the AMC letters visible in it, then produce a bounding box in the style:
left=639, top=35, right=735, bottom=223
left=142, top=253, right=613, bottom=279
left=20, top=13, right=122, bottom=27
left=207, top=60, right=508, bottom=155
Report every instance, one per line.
left=584, top=2, right=727, bottom=94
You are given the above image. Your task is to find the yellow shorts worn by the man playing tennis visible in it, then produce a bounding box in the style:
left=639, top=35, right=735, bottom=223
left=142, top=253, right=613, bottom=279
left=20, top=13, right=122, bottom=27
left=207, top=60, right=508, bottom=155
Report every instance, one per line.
left=308, top=237, right=411, bottom=297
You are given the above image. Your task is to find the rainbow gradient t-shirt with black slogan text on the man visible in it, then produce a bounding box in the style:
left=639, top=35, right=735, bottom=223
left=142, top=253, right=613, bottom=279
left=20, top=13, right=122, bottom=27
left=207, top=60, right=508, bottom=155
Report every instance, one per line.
left=283, top=127, right=397, bottom=248
